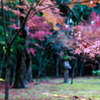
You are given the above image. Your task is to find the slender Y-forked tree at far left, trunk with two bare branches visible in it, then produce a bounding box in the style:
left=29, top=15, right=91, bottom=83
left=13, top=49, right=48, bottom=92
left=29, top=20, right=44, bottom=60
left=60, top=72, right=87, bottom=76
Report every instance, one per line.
left=1, top=0, right=34, bottom=100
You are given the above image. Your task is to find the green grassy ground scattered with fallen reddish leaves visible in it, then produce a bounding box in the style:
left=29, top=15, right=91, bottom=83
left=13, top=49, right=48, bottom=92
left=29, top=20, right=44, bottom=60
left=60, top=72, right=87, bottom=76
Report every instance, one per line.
left=0, top=77, right=100, bottom=100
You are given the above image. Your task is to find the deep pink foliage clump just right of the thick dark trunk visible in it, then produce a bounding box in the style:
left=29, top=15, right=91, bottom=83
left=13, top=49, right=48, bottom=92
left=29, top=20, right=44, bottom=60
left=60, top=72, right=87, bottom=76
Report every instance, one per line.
left=27, top=16, right=52, bottom=41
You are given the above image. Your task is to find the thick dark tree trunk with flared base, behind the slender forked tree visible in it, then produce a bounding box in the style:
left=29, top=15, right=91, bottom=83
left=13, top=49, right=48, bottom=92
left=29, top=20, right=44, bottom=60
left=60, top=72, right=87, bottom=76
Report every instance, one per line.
left=14, top=0, right=27, bottom=88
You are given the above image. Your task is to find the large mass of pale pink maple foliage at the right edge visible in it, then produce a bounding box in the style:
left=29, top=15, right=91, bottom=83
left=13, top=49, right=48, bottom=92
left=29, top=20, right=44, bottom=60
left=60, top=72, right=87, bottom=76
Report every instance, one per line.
left=73, top=11, right=100, bottom=57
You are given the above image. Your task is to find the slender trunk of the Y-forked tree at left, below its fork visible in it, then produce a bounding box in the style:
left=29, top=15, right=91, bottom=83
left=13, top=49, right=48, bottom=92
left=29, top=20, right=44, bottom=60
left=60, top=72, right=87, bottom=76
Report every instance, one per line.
left=5, top=46, right=11, bottom=100
